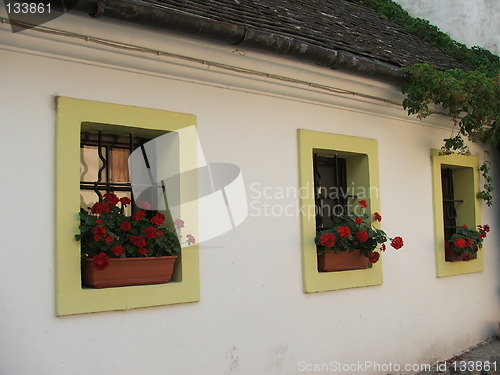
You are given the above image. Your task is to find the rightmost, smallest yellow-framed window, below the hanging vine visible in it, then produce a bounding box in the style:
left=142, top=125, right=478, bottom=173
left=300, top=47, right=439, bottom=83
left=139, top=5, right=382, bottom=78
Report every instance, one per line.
left=431, top=150, right=483, bottom=276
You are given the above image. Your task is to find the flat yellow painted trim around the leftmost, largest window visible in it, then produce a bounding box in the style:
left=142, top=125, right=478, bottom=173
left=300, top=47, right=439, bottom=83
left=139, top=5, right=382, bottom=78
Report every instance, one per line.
left=55, top=97, right=200, bottom=316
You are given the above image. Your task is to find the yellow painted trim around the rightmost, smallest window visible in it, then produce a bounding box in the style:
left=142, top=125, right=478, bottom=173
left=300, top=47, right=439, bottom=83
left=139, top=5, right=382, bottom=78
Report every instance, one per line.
left=431, top=150, right=484, bottom=277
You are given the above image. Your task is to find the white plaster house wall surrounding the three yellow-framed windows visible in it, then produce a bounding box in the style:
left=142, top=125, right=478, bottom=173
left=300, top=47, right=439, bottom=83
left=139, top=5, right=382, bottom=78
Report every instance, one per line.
left=0, top=13, right=500, bottom=375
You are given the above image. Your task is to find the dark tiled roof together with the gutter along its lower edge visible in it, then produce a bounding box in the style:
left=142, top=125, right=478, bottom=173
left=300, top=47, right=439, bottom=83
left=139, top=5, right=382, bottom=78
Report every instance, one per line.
left=71, top=0, right=463, bottom=81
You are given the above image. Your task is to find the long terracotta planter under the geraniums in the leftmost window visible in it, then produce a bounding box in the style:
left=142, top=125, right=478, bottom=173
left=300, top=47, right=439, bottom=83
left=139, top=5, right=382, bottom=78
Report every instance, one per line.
left=82, top=256, right=177, bottom=288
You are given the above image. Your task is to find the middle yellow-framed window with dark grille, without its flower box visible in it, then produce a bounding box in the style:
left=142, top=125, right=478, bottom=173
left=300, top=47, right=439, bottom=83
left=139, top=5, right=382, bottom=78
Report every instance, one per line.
left=298, top=130, right=382, bottom=292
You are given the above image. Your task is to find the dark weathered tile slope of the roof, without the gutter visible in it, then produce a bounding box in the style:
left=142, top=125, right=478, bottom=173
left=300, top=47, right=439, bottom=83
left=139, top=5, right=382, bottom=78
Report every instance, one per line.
left=150, top=0, right=461, bottom=69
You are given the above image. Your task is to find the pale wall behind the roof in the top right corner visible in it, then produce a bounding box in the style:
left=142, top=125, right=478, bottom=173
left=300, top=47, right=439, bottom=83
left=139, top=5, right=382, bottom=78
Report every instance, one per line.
left=395, top=0, right=500, bottom=54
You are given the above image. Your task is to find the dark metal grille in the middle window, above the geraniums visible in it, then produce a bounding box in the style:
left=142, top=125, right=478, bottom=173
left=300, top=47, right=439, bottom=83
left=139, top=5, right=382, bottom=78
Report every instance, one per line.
left=313, top=153, right=351, bottom=229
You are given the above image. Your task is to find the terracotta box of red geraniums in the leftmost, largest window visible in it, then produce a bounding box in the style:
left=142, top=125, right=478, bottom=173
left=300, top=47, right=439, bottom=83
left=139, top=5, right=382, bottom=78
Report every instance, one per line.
left=75, top=192, right=195, bottom=288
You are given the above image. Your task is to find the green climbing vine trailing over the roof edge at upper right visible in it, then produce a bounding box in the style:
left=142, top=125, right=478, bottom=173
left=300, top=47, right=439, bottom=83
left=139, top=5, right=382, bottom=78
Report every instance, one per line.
left=363, top=0, right=500, bottom=206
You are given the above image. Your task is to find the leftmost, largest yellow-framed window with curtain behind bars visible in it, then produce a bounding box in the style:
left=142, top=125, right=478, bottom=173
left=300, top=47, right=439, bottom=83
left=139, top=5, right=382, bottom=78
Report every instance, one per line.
left=55, top=97, right=200, bottom=315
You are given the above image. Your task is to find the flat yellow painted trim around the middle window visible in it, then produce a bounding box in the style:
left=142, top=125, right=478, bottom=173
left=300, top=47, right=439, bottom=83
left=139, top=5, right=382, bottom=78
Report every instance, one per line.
left=298, top=130, right=383, bottom=292
